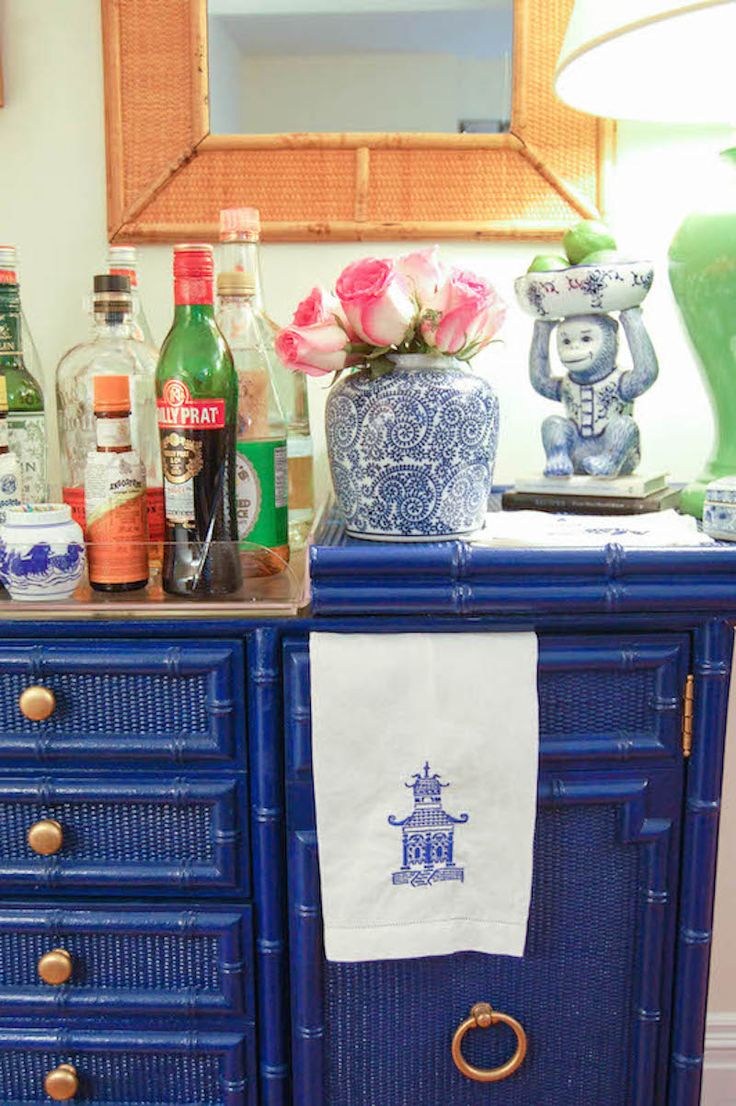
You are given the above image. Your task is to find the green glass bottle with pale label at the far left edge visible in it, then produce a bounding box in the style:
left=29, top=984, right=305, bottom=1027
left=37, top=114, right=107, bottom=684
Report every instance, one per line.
left=0, top=253, right=46, bottom=503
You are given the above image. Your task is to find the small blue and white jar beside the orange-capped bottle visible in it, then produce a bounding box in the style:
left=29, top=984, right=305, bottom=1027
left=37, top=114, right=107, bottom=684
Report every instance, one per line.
left=0, top=503, right=85, bottom=602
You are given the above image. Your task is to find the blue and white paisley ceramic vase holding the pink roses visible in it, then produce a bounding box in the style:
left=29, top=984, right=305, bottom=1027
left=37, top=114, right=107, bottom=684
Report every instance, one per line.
left=325, top=354, right=498, bottom=542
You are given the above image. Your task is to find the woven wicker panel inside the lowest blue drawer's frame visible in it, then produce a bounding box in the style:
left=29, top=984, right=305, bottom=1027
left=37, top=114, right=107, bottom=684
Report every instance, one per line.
left=0, top=1050, right=225, bottom=1106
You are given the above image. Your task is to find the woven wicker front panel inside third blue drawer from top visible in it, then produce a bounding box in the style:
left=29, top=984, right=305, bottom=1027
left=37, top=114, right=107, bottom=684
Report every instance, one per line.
left=0, top=929, right=222, bottom=1004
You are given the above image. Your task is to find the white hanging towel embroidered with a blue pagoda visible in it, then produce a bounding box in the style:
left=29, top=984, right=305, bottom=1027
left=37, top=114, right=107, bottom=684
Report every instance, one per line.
left=310, top=634, right=539, bottom=960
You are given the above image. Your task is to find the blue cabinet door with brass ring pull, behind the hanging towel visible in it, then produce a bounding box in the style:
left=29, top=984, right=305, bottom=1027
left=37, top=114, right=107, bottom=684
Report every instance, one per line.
left=286, top=636, right=687, bottom=1106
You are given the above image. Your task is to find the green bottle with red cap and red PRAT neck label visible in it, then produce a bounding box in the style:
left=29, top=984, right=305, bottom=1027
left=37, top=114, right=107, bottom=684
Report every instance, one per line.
left=156, top=244, right=241, bottom=597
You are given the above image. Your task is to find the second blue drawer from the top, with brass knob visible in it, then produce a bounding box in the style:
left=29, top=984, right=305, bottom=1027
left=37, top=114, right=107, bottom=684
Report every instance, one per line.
left=0, top=774, right=248, bottom=896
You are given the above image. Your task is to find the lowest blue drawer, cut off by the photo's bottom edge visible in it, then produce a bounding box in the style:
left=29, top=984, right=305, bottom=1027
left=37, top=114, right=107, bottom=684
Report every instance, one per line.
left=0, top=1027, right=257, bottom=1106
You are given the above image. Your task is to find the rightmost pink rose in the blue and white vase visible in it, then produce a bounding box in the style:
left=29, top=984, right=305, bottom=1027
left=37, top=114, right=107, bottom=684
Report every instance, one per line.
left=422, top=269, right=506, bottom=355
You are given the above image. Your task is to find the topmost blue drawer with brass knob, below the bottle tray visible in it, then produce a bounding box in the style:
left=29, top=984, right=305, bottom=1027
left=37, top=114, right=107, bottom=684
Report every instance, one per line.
left=0, top=641, right=245, bottom=764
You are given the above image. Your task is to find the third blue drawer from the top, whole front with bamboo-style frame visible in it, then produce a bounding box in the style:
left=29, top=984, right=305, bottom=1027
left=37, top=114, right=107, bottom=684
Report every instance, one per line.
left=0, top=905, right=253, bottom=1020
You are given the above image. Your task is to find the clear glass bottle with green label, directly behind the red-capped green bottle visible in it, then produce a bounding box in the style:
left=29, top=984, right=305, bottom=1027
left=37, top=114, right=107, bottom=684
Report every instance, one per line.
left=217, top=270, right=289, bottom=576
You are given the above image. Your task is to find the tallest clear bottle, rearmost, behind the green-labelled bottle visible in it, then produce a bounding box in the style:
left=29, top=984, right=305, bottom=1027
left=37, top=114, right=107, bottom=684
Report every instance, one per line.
left=215, top=207, right=314, bottom=550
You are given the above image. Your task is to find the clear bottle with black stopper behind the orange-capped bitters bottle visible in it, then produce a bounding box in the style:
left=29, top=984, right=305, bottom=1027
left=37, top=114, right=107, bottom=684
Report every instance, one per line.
left=56, top=273, right=164, bottom=539
